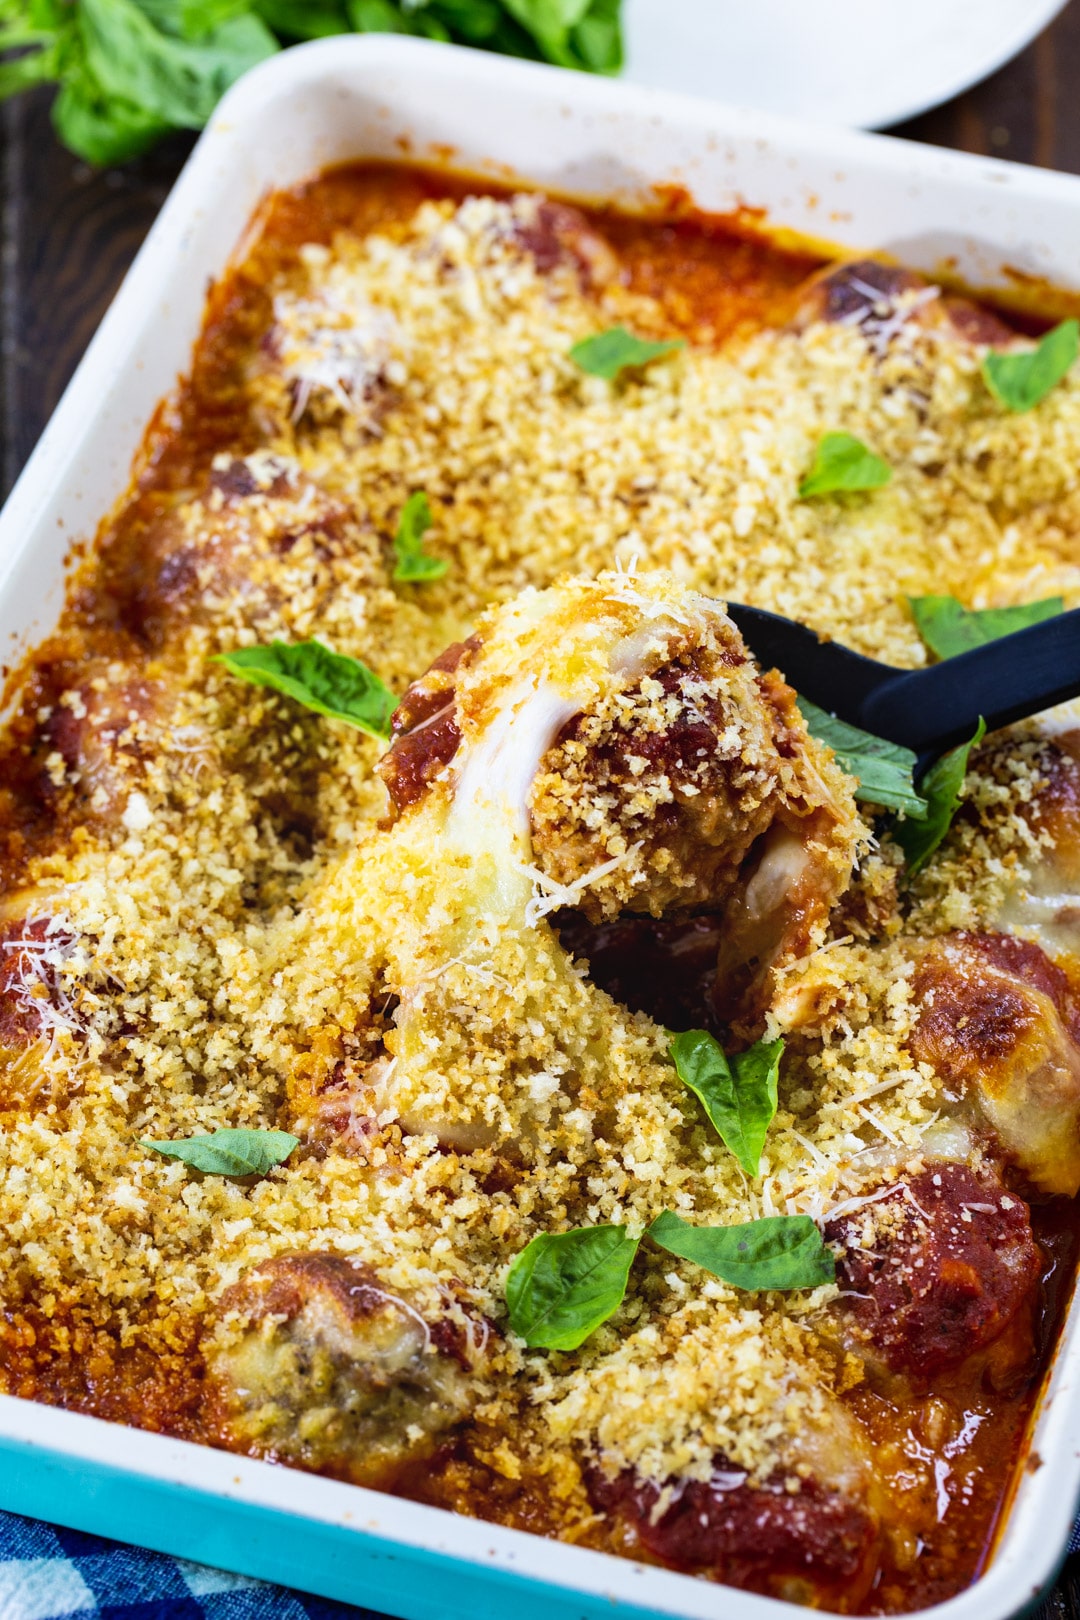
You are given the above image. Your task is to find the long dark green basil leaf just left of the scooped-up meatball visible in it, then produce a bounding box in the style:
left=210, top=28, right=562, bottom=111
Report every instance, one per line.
left=214, top=642, right=397, bottom=737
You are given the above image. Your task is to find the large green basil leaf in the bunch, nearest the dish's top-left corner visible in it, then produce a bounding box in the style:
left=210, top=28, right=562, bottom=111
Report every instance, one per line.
left=78, top=0, right=279, bottom=130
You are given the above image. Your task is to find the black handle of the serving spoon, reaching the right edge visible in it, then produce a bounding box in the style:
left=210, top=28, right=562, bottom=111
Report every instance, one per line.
left=861, top=608, right=1080, bottom=755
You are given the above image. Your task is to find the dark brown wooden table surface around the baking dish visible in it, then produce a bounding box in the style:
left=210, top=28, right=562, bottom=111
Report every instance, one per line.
left=0, top=0, right=1080, bottom=1620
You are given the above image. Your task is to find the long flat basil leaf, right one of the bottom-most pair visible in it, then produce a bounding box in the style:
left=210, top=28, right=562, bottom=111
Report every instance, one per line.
left=649, top=1210, right=836, bottom=1288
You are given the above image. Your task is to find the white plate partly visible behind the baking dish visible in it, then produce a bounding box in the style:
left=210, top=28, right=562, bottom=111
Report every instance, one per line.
left=623, top=0, right=1064, bottom=130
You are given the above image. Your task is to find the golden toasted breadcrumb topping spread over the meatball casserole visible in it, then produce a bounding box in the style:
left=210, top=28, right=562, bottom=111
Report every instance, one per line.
left=0, top=186, right=1080, bottom=1516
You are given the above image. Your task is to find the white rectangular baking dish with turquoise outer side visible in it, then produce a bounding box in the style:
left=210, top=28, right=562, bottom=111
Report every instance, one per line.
left=0, top=37, right=1080, bottom=1620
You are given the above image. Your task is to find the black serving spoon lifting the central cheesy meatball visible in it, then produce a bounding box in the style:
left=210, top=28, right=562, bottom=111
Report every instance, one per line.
left=727, top=603, right=1080, bottom=770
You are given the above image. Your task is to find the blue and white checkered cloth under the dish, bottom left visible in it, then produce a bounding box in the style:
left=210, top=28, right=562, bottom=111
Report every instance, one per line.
left=0, top=1510, right=384, bottom=1620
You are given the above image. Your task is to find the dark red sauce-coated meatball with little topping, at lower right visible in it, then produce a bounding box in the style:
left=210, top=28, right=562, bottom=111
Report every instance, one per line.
left=826, top=1160, right=1041, bottom=1387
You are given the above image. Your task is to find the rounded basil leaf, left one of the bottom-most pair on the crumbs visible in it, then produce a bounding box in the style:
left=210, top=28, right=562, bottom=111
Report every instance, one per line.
left=507, top=1226, right=638, bottom=1349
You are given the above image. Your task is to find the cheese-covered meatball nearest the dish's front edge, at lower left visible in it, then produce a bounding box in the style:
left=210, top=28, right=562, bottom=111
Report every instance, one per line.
left=207, top=1252, right=487, bottom=1486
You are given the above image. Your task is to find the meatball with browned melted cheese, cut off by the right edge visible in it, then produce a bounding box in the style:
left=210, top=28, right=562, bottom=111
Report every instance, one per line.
left=910, top=932, right=1080, bottom=1197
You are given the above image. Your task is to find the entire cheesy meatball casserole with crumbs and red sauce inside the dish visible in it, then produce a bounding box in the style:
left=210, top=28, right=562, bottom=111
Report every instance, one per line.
left=0, top=167, right=1080, bottom=1614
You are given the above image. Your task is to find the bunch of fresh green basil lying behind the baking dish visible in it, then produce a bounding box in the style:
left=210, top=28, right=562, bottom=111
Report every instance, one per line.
left=0, top=0, right=622, bottom=164
